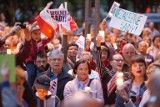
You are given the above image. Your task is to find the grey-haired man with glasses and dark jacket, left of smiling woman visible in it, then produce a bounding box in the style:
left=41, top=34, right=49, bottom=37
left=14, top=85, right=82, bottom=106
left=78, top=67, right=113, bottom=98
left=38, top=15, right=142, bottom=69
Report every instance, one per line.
left=45, top=50, right=72, bottom=100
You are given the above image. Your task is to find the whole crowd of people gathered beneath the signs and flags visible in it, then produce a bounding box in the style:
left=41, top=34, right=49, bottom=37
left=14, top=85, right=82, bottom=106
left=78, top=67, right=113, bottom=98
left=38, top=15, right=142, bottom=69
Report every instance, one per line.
left=0, top=1, right=160, bottom=107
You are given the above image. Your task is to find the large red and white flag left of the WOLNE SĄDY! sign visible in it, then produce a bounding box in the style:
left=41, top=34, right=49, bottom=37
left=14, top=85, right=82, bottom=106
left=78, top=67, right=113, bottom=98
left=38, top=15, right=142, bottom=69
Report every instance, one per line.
left=36, top=3, right=58, bottom=37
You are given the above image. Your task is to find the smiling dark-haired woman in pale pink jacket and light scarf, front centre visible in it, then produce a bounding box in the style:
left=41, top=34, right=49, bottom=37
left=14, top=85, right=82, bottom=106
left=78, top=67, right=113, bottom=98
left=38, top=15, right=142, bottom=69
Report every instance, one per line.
left=64, top=59, right=104, bottom=105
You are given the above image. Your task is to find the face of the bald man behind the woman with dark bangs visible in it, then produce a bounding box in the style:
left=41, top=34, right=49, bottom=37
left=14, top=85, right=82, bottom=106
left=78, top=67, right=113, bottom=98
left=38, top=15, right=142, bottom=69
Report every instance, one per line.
left=123, top=46, right=135, bottom=64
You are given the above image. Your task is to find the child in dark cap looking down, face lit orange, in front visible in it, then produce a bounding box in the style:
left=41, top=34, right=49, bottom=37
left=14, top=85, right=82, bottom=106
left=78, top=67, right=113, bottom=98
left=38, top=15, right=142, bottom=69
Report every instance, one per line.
left=34, top=75, right=60, bottom=107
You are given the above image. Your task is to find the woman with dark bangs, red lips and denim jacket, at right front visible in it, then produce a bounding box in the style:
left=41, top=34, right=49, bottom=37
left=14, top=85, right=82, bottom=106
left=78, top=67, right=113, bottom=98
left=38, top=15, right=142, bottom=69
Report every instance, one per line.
left=116, top=55, right=147, bottom=107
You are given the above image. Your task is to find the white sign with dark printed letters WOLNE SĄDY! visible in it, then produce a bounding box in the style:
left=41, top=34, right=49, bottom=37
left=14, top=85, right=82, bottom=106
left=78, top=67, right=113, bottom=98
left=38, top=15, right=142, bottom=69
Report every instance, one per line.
left=48, top=9, right=67, bottom=24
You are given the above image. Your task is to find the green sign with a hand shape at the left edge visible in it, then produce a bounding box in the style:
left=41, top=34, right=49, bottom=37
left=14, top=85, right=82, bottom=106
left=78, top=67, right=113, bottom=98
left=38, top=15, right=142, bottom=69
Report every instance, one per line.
left=0, top=55, right=15, bottom=83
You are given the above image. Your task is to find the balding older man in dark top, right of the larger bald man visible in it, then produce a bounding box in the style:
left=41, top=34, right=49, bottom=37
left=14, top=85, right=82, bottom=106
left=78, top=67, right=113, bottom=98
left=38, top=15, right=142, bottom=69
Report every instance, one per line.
left=138, top=41, right=154, bottom=65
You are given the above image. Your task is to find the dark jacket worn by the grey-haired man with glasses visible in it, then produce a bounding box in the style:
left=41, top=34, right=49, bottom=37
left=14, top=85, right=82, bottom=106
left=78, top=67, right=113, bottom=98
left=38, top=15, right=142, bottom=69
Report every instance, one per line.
left=44, top=67, right=73, bottom=100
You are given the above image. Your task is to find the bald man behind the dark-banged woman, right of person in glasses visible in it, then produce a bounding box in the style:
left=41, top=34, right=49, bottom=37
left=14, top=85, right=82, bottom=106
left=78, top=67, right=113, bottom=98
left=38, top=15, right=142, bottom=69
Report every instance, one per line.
left=122, top=43, right=136, bottom=72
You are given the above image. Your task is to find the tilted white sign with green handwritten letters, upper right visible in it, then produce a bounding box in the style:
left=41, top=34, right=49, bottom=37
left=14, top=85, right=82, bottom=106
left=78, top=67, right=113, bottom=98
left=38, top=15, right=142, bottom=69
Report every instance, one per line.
left=110, top=8, right=147, bottom=35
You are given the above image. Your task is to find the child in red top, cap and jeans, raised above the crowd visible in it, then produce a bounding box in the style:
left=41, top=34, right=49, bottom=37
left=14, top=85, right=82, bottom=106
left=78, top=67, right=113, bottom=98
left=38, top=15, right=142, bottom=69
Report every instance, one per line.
left=25, top=23, right=53, bottom=87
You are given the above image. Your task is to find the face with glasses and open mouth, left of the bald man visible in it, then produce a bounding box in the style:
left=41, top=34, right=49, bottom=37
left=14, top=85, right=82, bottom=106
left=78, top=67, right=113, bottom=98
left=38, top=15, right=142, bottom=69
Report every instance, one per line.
left=110, top=54, right=124, bottom=71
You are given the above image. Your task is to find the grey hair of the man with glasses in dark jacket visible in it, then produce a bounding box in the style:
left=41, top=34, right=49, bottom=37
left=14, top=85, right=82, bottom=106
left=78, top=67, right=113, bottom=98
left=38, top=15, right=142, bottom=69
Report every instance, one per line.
left=48, top=49, right=64, bottom=60
